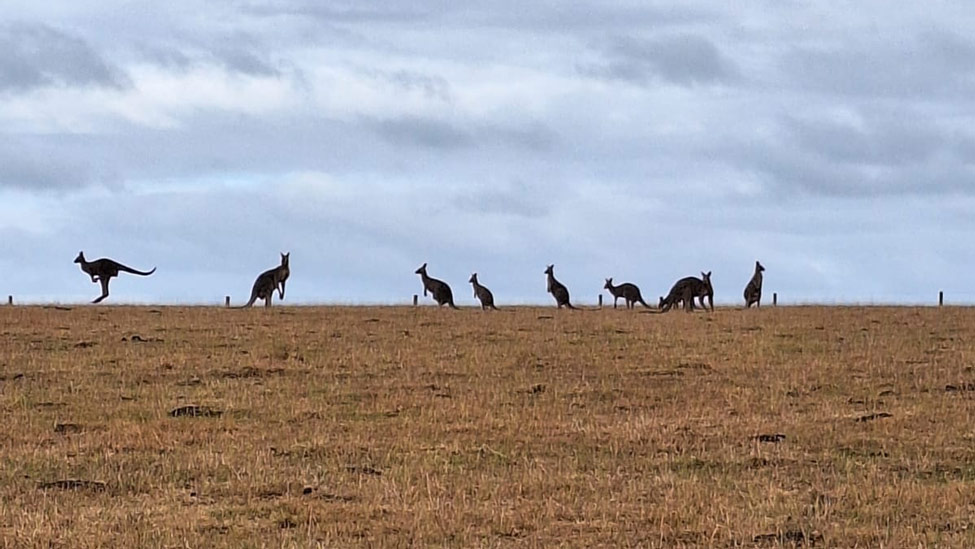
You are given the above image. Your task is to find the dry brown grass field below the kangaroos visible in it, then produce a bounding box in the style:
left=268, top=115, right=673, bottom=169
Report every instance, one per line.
left=0, top=306, right=975, bottom=548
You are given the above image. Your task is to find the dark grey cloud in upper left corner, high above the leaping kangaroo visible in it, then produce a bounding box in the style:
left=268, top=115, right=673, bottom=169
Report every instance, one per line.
left=0, top=23, right=128, bottom=91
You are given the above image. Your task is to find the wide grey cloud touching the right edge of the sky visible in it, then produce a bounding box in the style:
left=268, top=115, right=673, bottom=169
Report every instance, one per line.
left=708, top=111, right=975, bottom=197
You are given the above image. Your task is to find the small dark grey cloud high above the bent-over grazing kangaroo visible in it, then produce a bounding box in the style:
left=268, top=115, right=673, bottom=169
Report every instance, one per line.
left=579, top=34, right=737, bottom=86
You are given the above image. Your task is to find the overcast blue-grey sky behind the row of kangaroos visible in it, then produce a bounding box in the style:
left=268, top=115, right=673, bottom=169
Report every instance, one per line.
left=0, top=0, right=975, bottom=304
